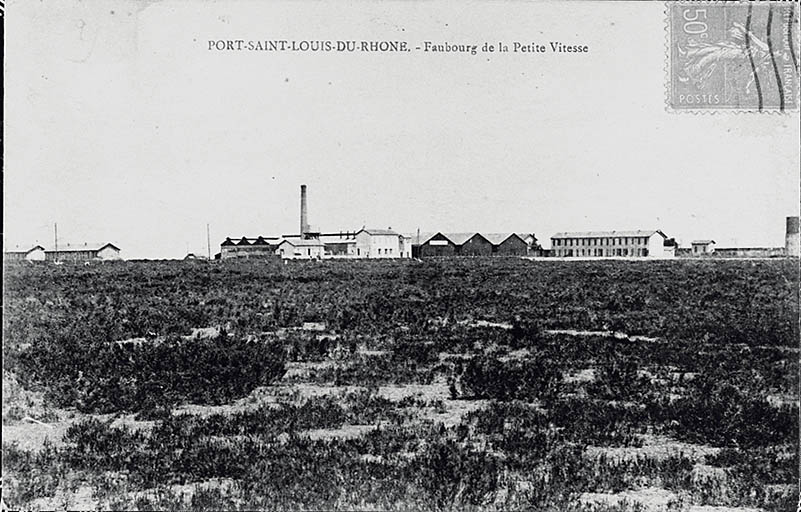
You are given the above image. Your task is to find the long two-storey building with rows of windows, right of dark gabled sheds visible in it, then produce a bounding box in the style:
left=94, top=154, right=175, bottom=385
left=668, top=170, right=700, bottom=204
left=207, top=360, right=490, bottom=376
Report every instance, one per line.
left=551, top=229, right=667, bottom=258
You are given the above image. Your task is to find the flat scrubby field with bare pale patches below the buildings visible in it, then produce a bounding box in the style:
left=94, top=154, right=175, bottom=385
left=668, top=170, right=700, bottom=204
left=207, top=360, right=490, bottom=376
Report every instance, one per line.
left=3, top=259, right=799, bottom=512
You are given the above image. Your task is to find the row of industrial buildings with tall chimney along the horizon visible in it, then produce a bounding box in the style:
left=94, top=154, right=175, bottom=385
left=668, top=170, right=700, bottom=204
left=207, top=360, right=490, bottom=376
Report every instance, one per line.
left=4, top=185, right=801, bottom=263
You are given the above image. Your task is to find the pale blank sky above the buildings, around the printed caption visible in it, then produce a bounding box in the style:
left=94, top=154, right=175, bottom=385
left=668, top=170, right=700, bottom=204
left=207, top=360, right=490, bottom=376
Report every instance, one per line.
left=3, top=0, right=801, bottom=258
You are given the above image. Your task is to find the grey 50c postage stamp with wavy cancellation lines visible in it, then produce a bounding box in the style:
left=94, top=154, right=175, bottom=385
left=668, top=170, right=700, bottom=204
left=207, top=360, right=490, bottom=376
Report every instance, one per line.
left=666, top=2, right=799, bottom=112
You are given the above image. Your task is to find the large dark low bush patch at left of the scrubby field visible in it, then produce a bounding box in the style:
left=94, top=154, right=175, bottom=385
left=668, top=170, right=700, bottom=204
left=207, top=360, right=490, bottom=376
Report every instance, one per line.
left=22, top=336, right=285, bottom=414
